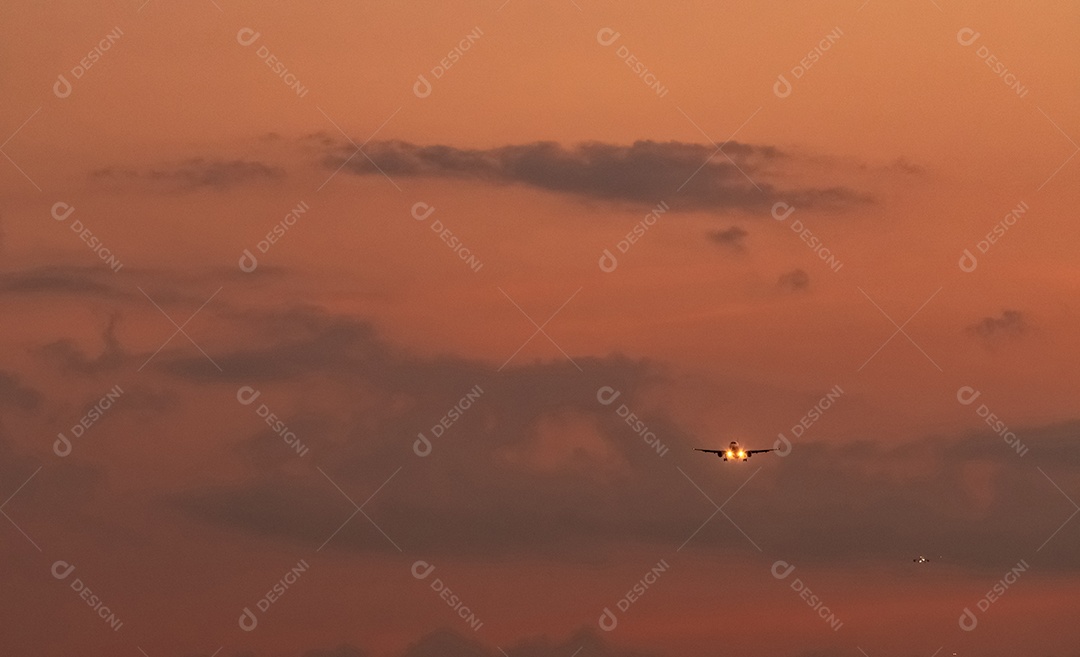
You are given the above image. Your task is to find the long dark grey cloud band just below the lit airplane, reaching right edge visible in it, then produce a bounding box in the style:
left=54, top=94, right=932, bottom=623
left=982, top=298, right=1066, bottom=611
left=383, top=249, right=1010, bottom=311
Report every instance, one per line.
left=173, top=415, right=1080, bottom=571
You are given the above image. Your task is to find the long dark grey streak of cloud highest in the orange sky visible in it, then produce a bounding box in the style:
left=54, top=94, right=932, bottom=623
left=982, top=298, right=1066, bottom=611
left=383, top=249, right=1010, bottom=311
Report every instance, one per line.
left=323, top=140, right=870, bottom=214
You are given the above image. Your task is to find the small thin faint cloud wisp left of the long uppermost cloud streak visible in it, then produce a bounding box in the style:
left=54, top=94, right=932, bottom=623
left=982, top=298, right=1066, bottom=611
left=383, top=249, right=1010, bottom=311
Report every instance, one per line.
left=90, top=158, right=285, bottom=191
